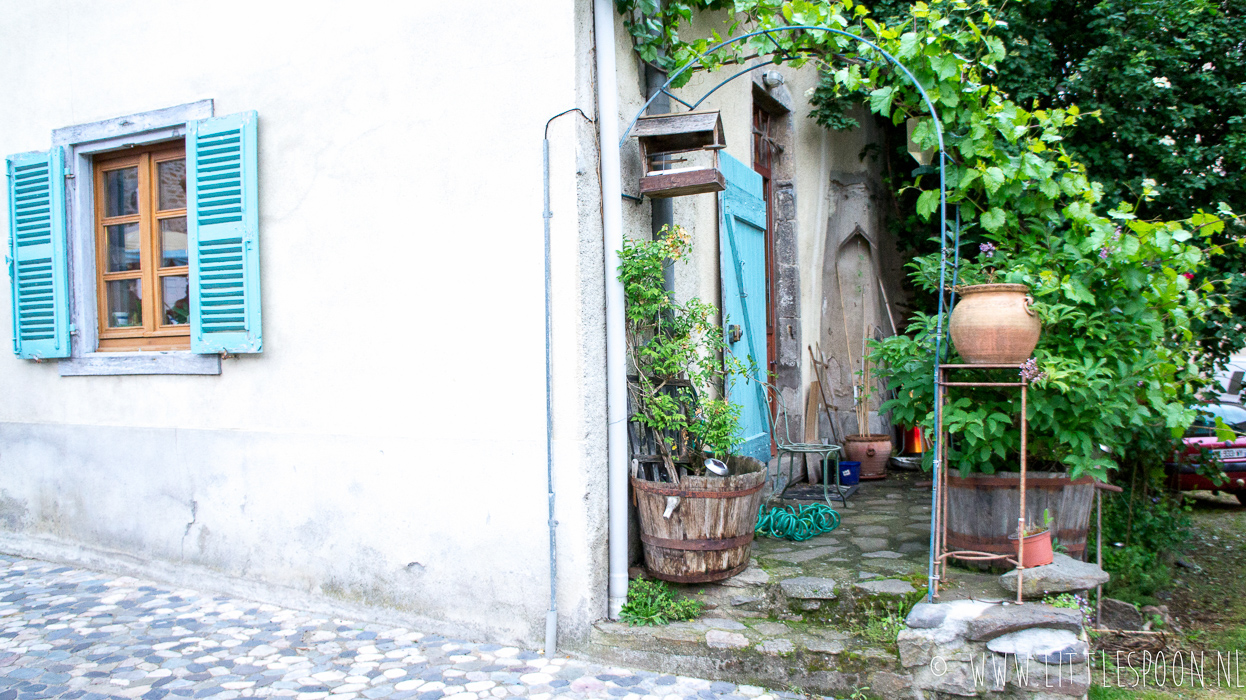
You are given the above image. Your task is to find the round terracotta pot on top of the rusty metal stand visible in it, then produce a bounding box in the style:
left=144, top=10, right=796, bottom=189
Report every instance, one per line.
left=952, top=284, right=1043, bottom=365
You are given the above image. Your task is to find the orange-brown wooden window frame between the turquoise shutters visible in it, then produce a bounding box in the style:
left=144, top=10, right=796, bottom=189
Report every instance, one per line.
left=92, top=140, right=191, bottom=351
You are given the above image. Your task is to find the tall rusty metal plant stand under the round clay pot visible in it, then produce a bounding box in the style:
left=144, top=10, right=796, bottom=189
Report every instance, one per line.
left=931, top=365, right=1029, bottom=603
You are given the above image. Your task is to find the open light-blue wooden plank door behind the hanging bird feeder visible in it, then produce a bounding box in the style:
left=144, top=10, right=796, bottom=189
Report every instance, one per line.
left=718, top=153, right=770, bottom=462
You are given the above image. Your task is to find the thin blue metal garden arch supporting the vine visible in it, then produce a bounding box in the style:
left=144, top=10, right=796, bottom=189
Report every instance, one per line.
left=619, top=25, right=961, bottom=602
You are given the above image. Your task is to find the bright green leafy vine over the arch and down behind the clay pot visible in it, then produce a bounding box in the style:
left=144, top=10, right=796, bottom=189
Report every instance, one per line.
left=618, top=0, right=1241, bottom=478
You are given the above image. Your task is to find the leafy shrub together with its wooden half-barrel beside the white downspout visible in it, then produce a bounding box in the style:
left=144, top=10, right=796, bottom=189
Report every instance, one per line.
left=619, top=227, right=766, bottom=583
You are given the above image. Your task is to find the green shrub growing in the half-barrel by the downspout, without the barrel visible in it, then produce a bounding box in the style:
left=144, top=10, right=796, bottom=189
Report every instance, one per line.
left=619, top=227, right=744, bottom=473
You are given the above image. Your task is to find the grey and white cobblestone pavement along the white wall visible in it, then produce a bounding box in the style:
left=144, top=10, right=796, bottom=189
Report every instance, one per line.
left=0, top=556, right=817, bottom=700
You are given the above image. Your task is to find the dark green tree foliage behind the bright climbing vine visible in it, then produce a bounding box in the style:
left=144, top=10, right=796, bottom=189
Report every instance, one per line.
left=867, top=0, right=1246, bottom=367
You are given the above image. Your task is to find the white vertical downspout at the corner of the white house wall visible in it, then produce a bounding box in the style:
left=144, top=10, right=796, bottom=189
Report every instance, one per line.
left=593, top=0, right=628, bottom=619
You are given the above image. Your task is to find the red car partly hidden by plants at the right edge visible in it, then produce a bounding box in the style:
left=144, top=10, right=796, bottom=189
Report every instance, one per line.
left=1168, top=404, right=1246, bottom=506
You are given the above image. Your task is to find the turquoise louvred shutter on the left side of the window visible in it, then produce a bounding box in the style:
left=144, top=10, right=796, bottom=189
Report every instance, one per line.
left=7, top=147, right=70, bottom=360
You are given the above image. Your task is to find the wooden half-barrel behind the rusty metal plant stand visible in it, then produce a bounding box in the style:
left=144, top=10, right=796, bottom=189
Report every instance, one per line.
left=947, top=470, right=1094, bottom=565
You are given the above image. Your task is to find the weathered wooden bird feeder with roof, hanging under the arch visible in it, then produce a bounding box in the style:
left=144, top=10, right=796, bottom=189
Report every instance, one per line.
left=633, top=112, right=726, bottom=198
